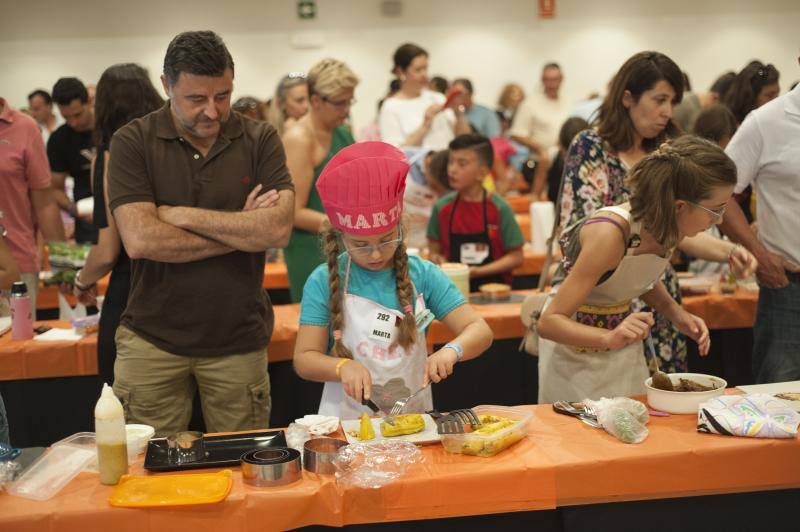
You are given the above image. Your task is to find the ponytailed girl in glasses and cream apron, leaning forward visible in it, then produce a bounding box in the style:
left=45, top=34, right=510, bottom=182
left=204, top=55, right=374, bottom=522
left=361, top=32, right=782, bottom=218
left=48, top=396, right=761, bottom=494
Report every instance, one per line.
left=539, top=136, right=755, bottom=403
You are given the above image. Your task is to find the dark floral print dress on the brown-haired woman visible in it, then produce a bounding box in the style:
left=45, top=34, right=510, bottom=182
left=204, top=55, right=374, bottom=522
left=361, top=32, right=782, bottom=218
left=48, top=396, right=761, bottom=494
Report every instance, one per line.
left=560, top=129, right=688, bottom=373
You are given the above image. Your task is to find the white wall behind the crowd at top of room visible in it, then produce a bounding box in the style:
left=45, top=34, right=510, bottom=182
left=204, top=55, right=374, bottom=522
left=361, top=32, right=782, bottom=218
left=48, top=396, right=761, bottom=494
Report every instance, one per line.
left=0, top=0, right=800, bottom=131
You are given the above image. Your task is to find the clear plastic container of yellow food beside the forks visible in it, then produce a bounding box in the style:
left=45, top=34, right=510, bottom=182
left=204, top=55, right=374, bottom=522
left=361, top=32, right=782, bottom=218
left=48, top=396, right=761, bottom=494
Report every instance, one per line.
left=442, top=405, right=533, bottom=457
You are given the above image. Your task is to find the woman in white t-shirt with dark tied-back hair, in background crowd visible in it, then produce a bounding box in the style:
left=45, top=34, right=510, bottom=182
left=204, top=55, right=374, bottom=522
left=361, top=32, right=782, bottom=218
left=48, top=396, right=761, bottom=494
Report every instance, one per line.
left=378, top=43, right=471, bottom=150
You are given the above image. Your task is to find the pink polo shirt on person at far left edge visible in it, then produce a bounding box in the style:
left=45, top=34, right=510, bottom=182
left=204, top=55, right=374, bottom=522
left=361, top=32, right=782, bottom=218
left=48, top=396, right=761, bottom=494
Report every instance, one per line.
left=0, top=98, right=50, bottom=273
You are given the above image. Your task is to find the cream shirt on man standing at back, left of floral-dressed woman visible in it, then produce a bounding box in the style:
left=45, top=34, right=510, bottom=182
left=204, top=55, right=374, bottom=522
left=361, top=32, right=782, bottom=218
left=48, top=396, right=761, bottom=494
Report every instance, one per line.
left=510, top=93, right=570, bottom=149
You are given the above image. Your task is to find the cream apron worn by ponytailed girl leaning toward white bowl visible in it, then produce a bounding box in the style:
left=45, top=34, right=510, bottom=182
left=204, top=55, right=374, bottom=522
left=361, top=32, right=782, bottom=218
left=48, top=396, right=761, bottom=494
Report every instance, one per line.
left=539, top=207, right=669, bottom=403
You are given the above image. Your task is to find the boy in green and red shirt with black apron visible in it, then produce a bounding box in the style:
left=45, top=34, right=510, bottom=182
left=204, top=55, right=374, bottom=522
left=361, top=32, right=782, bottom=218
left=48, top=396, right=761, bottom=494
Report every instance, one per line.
left=428, top=134, right=525, bottom=292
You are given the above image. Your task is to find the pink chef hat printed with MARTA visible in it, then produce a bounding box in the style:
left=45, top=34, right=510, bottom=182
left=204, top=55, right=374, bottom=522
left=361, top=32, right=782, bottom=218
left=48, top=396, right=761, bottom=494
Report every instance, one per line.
left=317, top=142, right=408, bottom=236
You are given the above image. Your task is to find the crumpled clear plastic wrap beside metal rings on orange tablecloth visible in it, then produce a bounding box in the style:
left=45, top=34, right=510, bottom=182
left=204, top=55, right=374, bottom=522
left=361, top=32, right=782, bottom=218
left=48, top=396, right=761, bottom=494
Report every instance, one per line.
left=333, top=440, right=424, bottom=489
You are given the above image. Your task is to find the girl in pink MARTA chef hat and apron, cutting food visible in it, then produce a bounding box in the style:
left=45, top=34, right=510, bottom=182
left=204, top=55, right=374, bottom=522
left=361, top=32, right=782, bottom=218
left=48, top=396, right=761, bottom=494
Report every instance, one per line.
left=294, top=142, right=492, bottom=419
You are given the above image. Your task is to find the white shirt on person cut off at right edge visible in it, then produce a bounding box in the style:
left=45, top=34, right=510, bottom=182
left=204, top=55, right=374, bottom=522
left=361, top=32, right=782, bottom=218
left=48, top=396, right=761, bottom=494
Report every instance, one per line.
left=725, top=86, right=800, bottom=268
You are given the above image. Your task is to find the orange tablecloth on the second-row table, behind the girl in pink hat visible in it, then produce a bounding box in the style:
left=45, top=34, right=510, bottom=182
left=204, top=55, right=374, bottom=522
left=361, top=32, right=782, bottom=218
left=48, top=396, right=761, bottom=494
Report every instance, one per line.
left=0, top=290, right=758, bottom=380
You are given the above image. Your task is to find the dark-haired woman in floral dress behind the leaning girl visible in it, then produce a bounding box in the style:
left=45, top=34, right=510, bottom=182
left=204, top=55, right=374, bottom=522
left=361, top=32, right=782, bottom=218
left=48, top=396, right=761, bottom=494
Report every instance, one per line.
left=561, top=52, right=755, bottom=372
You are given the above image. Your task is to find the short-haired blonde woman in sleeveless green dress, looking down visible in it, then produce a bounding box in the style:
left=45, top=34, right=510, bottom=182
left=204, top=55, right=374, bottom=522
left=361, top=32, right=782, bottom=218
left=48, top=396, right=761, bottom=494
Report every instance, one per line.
left=282, top=59, right=359, bottom=303
